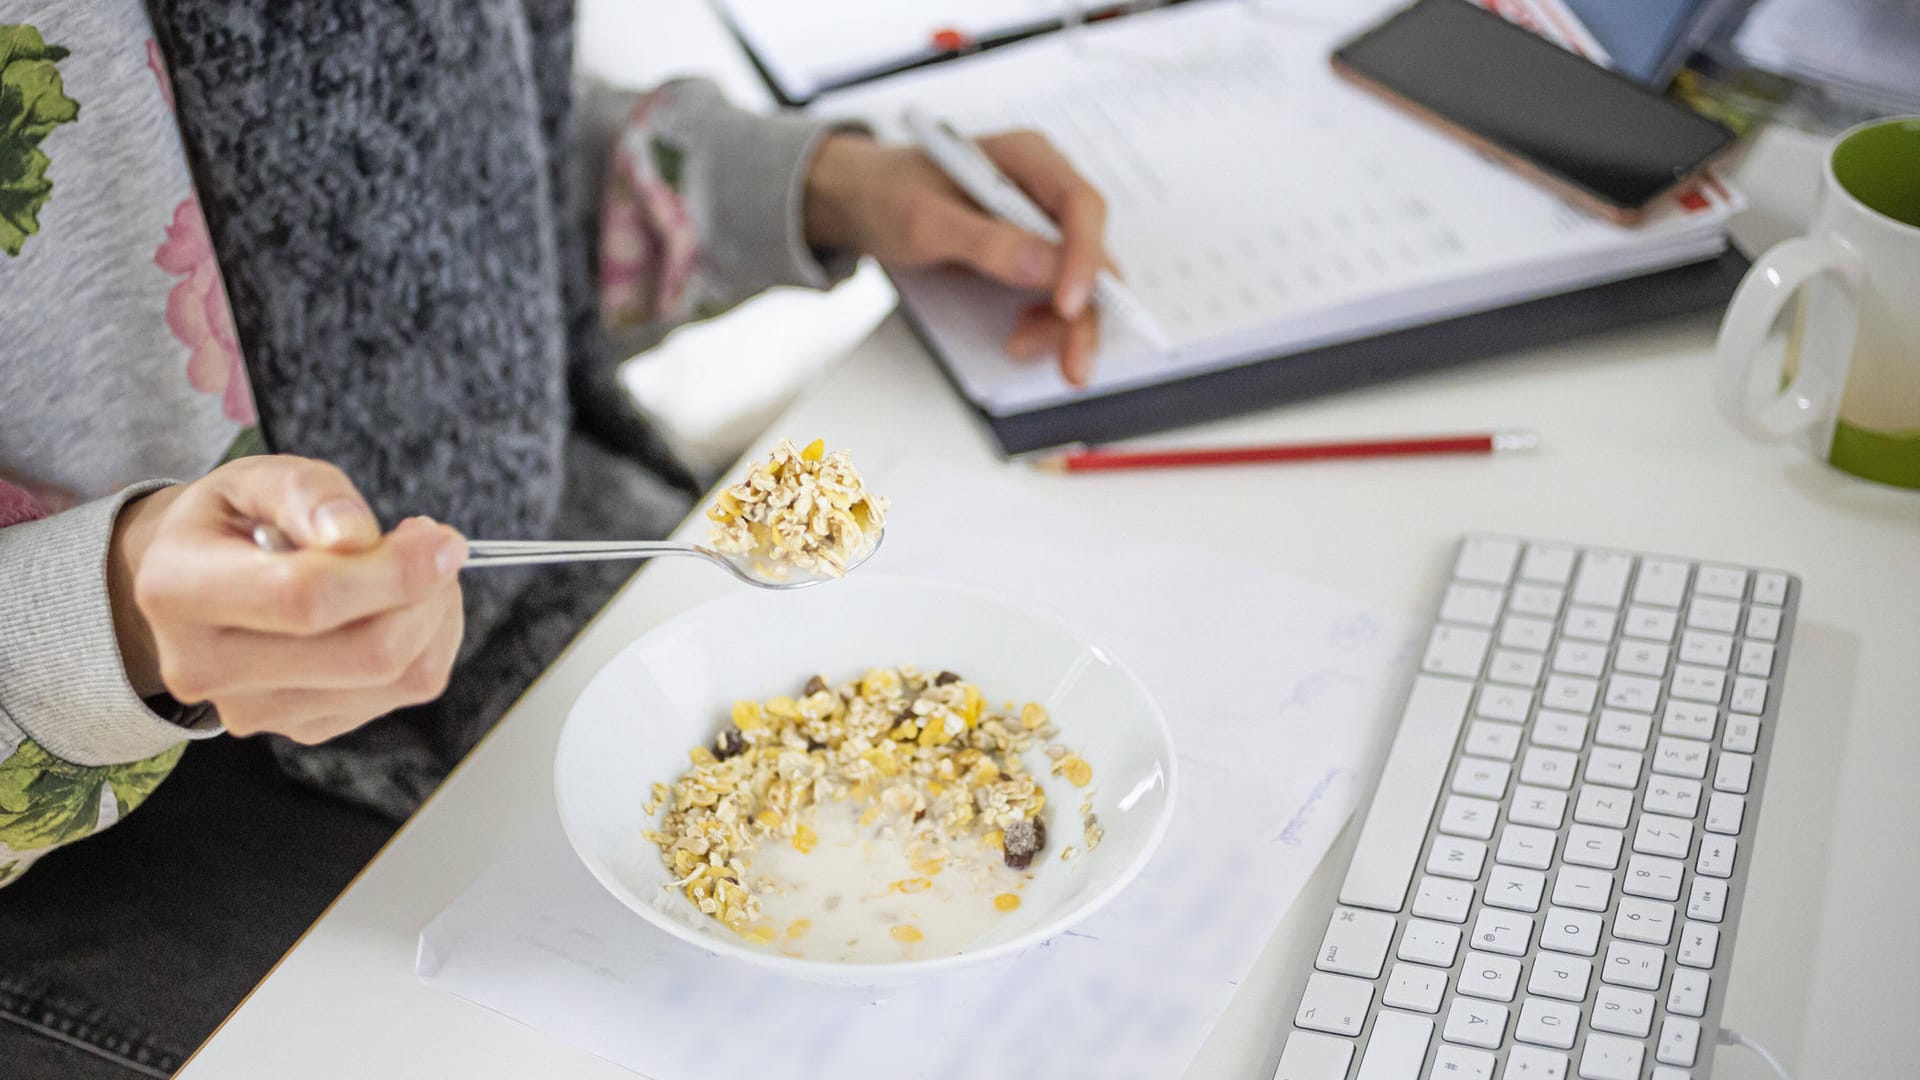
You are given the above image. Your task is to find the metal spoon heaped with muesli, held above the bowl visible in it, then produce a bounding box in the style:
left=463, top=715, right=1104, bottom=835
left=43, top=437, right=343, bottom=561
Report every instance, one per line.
left=253, top=438, right=887, bottom=588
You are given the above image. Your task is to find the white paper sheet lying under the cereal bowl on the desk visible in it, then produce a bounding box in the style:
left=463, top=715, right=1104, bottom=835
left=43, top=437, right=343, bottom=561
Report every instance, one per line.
left=420, top=461, right=1415, bottom=1080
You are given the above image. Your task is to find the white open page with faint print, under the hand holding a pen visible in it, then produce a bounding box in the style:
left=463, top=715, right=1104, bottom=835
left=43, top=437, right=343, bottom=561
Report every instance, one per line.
left=820, top=0, right=1732, bottom=413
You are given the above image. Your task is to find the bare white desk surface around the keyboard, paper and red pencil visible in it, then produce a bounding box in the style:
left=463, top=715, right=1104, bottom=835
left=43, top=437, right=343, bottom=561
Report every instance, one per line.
left=182, top=134, right=1920, bottom=1080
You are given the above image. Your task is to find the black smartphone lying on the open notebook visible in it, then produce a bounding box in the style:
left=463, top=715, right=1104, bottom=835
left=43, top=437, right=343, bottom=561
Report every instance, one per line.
left=1332, top=0, right=1734, bottom=225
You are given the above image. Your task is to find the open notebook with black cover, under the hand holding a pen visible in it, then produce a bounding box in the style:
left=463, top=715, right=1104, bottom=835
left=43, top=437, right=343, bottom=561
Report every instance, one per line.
left=756, top=0, right=1741, bottom=452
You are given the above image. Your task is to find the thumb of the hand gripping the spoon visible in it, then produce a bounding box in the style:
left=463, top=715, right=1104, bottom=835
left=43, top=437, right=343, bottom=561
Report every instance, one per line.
left=209, top=455, right=380, bottom=553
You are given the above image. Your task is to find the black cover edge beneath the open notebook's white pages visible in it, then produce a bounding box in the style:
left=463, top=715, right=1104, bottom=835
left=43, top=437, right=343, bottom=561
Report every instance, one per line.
left=900, top=244, right=1747, bottom=454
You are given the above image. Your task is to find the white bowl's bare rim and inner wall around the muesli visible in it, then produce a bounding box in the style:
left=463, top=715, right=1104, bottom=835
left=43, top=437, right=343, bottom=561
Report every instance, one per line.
left=553, top=575, right=1175, bottom=986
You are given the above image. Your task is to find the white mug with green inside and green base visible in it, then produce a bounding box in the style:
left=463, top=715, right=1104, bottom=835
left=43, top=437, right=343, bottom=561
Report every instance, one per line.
left=1715, top=117, right=1920, bottom=488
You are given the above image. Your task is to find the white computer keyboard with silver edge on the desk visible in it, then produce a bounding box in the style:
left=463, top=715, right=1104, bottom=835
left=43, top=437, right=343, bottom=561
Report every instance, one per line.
left=1275, top=536, right=1799, bottom=1080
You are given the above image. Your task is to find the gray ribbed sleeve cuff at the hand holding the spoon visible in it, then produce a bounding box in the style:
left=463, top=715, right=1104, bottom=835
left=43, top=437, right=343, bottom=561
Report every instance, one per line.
left=0, top=480, right=221, bottom=765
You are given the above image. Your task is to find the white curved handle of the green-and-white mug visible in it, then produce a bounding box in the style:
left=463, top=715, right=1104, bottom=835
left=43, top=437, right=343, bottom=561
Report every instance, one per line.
left=1715, top=236, right=1860, bottom=440
